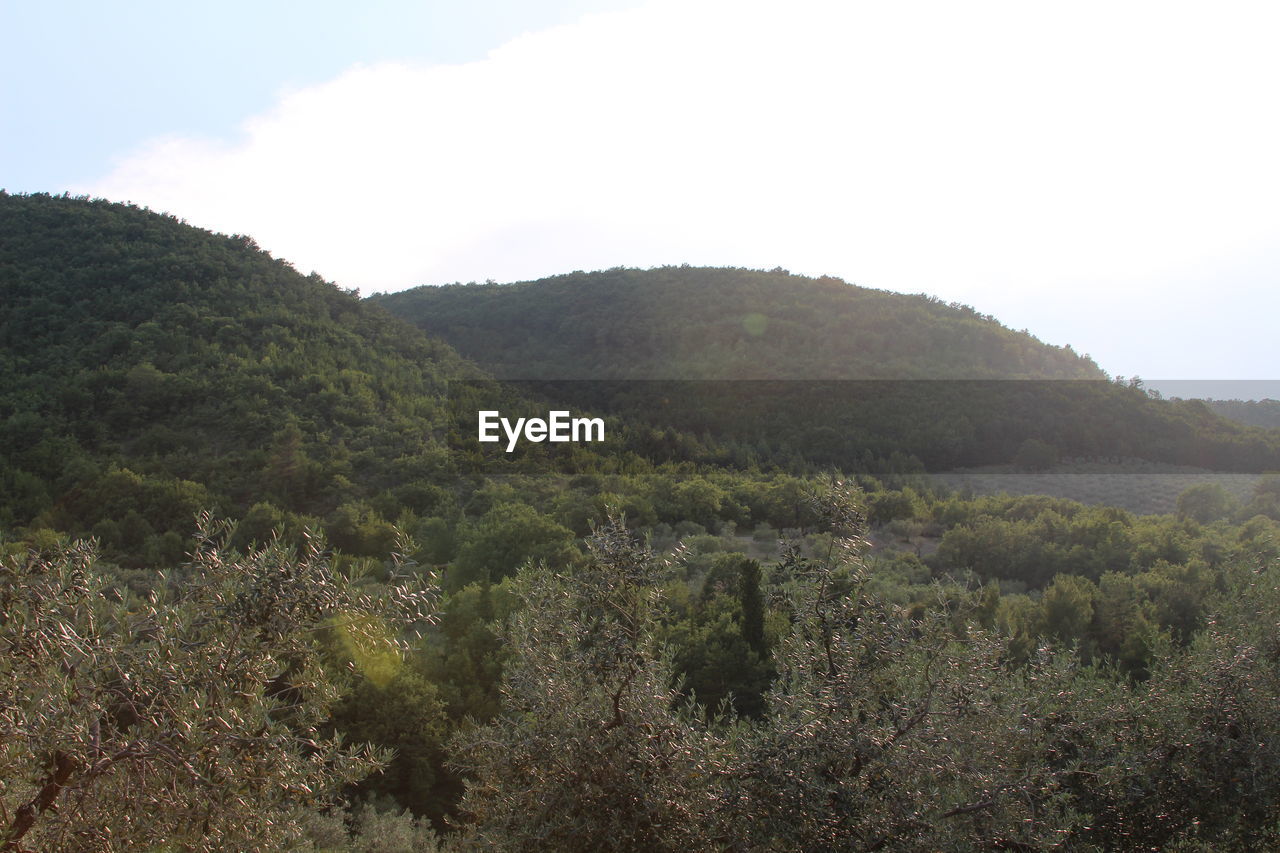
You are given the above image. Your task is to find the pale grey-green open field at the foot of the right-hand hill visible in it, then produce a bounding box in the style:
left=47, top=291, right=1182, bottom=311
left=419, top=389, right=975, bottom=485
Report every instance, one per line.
left=933, top=460, right=1261, bottom=515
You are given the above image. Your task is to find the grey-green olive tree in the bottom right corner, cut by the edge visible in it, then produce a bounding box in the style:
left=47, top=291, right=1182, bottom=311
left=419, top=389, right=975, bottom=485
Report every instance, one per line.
left=1068, top=550, right=1280, bottom=850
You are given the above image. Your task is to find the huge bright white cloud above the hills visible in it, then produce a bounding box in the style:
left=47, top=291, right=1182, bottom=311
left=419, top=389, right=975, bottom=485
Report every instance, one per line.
left=83, top=0, right=1280, bottom=371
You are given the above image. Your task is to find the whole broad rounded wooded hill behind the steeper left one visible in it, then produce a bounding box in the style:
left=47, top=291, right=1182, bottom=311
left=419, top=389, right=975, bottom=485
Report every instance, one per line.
left=371, top=266, right=1280, bottom=471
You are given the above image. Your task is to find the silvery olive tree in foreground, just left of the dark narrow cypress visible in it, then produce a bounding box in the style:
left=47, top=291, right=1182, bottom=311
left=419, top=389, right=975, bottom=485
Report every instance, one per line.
left=454, top=521, right=732, bottom=850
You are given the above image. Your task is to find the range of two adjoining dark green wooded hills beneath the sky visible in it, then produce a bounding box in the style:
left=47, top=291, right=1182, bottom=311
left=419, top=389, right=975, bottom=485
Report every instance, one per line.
left=0, top=193, right=1280, bottom=571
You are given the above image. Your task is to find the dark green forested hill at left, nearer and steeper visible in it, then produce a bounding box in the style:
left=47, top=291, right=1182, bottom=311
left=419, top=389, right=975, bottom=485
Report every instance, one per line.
left=0, top=193, right=479, bottom=561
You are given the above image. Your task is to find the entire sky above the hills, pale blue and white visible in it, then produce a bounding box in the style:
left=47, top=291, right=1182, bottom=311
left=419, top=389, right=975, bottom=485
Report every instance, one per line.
left=0, top=0, right=1280, bottom=386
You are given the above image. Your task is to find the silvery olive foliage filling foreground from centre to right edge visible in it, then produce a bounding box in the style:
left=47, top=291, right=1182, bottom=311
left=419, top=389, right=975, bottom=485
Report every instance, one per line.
left=442, top=489, right=1280, bottom=850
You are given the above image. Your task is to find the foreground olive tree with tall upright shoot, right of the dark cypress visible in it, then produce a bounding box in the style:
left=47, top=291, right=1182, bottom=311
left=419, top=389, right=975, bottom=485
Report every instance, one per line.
left=716, top=484, right=1087, bottom=850
